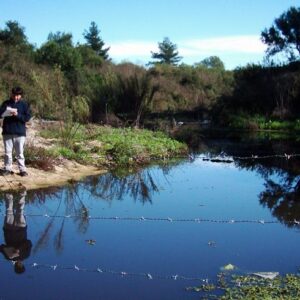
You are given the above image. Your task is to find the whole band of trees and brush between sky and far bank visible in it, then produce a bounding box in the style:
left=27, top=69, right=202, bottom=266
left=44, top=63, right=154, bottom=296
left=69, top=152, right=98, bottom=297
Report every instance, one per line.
left=0, top=8, right=300, bottom=126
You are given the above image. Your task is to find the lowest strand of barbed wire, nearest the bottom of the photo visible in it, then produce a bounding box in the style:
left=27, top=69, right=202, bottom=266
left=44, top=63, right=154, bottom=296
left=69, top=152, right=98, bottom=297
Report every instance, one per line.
left=31, top=262, right=209, bottom=284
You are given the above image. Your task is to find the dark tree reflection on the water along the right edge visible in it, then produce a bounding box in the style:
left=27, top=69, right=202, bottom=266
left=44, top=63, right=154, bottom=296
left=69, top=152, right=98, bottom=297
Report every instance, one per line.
left=199, top=139, right=300, bottom=227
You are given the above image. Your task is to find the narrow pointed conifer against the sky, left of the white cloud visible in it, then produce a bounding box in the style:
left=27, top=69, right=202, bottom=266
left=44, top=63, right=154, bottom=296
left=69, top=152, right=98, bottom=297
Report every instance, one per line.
left=83, top=22, right=110, bottom=60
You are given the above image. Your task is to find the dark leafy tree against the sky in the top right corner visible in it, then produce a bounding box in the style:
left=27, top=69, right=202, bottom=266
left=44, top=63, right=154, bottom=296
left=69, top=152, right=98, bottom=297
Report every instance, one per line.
left=261, top=7, right=300, bottom=61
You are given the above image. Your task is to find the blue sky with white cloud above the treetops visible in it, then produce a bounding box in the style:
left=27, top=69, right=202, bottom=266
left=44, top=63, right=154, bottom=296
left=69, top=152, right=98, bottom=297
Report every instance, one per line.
left=0, top=0, right=300, bottom=70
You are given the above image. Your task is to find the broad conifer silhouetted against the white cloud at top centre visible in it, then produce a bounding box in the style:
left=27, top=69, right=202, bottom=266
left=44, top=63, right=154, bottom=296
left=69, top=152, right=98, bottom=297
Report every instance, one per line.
left=150, top=37, right=182, bottom=65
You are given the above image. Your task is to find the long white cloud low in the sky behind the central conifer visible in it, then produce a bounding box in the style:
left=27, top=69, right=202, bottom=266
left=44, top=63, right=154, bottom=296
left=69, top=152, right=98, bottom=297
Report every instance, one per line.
left=108, top=35, right=266, bottom=68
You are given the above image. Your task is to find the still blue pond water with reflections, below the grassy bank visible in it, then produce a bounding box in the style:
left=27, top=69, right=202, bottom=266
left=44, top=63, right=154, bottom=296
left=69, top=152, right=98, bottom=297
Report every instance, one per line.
left=0, top=134, right=300, bottom=299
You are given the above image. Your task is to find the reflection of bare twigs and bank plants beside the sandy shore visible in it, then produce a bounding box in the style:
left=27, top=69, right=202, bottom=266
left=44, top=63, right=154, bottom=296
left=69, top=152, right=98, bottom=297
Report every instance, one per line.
left=0, top=161, right=179, bottom=253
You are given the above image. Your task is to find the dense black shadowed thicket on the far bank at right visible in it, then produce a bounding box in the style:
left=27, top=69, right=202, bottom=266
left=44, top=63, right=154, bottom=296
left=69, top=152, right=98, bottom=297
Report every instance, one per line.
left=214, top=61, right=300, bottom=123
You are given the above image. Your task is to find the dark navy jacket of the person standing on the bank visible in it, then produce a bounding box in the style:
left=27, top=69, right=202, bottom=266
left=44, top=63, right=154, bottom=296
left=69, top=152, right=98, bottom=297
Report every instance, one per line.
left=0, top=99, right=31, bottom=136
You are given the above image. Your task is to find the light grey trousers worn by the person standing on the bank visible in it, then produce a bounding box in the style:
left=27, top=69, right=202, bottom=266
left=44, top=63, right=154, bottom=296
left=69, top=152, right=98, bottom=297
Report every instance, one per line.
left=3, top=134, right=26, bottom=172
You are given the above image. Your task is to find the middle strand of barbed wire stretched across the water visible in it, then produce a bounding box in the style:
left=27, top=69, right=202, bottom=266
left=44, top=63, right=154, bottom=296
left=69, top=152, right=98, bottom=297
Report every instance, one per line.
left=1, top=213, right=300, bottom=225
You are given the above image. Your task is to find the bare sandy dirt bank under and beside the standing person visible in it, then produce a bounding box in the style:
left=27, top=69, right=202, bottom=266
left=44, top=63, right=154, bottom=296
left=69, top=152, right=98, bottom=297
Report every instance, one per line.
left=0, top=120, right=107, bottom=191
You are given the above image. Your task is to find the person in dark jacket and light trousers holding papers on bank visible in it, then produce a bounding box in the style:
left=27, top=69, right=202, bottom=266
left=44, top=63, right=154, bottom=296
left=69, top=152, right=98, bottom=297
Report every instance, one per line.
left=0, top=87, right=31, bottom=176
